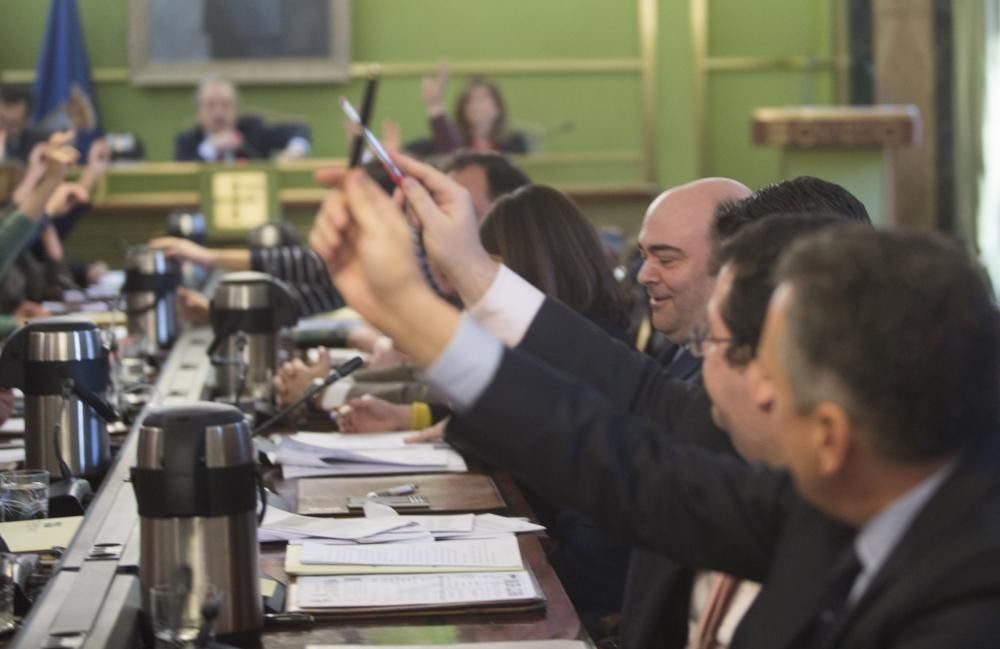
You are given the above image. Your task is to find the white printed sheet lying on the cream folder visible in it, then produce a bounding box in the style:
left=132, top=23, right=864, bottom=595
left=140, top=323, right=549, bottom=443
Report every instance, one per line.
left=300, top=532, right=522, bottom=568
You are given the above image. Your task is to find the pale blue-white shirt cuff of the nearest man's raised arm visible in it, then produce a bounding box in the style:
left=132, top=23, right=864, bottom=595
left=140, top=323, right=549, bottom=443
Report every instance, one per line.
left=423, top=316, right=503, bottom=412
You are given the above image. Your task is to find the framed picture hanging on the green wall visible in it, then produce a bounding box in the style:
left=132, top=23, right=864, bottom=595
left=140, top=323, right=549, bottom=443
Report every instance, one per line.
left=129, top=0, right=351, bottom=85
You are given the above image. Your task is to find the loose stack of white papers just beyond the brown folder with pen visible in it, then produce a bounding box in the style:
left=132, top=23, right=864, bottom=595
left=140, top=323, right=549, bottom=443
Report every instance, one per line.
left=271, top=432, right=468, bottom=478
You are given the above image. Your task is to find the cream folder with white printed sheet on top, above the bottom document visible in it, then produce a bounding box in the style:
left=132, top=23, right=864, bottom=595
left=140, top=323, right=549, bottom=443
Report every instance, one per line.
left=285, top=535, right=523, bottom=575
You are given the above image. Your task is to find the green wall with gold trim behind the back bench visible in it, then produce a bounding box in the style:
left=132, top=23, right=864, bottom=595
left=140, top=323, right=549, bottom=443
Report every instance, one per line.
left=0, top=0, right=833, bottom=191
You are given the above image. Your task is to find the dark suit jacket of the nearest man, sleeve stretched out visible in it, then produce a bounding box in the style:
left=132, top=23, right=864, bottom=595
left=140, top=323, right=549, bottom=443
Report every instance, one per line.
left=448, top=334, right=1000, bottom=649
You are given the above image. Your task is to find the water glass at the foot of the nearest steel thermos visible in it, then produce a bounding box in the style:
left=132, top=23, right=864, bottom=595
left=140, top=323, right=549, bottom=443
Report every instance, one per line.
left=149, top=584, right=222, bottom=649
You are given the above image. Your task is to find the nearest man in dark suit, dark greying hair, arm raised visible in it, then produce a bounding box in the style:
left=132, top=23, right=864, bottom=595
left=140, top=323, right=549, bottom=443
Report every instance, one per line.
left=313, top=168, right=1000, bottom=647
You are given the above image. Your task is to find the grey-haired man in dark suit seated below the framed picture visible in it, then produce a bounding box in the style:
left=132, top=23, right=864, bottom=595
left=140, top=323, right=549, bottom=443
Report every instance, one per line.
left=174, top=78, right=310, bottom=162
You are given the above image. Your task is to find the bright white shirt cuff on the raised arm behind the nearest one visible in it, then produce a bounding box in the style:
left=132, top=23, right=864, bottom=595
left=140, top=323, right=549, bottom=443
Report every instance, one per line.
left=467, top=266, right=545, bottom=347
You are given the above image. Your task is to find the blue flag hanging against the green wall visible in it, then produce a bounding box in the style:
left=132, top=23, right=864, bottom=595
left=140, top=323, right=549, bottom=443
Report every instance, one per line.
left=31, top=0, right=101, bottom=155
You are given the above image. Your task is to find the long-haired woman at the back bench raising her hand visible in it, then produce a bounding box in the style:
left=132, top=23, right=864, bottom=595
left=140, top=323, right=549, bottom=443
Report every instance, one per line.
left=421, top=65, right=528, bottom=154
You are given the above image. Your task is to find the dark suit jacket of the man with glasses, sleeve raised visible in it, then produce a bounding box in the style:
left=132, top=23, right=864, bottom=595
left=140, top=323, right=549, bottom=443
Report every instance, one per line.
left=519, top=301, right=735, bottom=649
